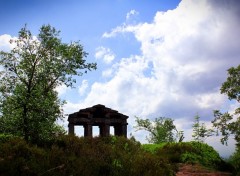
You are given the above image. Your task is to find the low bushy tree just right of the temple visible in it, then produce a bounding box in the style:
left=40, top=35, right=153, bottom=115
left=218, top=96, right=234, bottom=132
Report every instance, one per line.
left=134, top=117, right=184, bottom=144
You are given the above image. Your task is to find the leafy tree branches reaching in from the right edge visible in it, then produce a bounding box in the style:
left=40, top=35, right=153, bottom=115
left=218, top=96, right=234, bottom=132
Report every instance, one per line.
left=212, top=65, right=240, bottom=148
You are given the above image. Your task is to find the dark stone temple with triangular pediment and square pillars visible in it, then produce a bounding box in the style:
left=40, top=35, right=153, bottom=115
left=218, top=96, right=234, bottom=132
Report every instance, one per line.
left=68, top=104, right=128, bottom=137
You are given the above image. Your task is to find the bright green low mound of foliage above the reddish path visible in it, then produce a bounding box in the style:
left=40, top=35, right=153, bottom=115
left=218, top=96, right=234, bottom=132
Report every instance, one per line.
left=143, top=141, right=231, bottom=171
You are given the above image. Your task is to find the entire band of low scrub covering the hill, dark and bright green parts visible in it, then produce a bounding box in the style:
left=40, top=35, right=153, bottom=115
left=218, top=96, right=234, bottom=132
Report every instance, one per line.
left=0, top=135, right=233, bottom=176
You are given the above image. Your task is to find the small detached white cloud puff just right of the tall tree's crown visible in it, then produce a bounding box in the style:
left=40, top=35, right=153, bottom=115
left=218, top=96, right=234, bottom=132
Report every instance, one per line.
left=95, top=46, right=115, bottom=64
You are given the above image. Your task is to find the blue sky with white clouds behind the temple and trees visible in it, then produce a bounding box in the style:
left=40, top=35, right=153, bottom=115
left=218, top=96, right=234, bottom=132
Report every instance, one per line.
left=0, top=0, right=240, bottom=157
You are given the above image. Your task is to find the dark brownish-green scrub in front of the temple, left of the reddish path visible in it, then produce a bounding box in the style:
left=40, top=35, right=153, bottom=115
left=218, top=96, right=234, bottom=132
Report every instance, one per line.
left=0, top=136, right=174, bottom=176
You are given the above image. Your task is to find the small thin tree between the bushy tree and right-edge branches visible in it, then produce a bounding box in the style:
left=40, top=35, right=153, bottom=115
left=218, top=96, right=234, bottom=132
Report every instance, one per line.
left=192, top=115, right=213, bottom=143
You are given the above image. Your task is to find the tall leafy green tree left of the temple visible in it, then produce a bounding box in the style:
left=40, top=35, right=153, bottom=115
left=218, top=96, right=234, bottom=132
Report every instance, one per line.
left=0, top=25, right=96, bottom=141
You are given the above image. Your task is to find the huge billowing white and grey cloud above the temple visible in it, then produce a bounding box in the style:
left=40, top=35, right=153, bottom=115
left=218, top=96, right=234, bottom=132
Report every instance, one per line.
left=64, top=0, right=240, bottom=155
